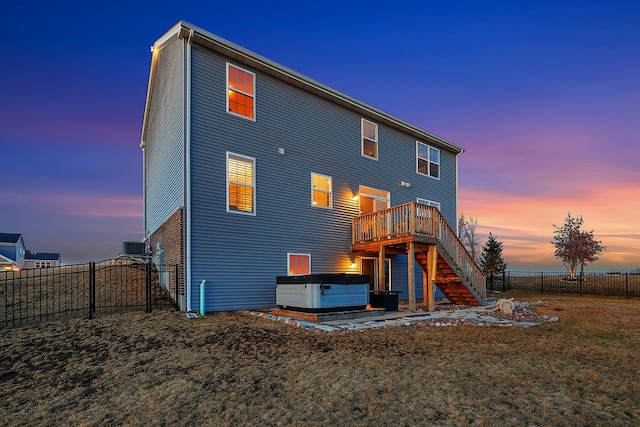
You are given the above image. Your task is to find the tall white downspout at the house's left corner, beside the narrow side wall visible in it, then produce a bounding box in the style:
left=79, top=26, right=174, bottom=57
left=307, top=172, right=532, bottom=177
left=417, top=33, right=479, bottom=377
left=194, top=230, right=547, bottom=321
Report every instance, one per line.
left=184, top=29, right=193, bottom=312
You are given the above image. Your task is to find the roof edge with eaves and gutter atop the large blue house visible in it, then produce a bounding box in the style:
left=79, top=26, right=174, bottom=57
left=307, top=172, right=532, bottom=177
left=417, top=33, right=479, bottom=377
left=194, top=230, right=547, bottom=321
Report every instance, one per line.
left=140, top=21, right=465, bottom=154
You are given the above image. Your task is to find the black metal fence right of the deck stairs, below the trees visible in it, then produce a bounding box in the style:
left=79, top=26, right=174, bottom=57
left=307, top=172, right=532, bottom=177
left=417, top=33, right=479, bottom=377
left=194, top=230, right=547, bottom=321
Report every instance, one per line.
left=487, top=271, right=640, bottom=298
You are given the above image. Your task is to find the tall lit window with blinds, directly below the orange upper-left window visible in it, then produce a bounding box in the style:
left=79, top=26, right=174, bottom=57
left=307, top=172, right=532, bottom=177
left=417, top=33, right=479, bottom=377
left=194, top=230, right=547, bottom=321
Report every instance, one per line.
left=227, top=152, right=256, bottom=215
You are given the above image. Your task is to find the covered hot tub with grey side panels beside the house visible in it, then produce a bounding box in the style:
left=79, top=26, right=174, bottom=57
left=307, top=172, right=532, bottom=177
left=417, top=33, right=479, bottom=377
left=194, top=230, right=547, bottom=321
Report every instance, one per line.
left=276, top=273, right=369, bottom=313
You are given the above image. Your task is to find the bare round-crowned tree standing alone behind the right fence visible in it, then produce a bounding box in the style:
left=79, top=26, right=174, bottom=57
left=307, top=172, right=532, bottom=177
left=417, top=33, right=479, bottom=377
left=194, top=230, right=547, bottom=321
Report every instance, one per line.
left=551, top=212, right=606, bottom=279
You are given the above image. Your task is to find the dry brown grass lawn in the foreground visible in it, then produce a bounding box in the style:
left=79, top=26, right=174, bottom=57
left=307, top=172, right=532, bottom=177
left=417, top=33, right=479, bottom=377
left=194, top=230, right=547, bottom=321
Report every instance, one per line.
left=0, top=294, right=640, bottom=426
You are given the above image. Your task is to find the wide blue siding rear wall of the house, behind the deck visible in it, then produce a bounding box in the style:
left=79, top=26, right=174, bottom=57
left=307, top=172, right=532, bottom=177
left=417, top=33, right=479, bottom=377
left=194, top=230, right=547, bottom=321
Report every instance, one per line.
left=190, top=46, right=456, bottom=311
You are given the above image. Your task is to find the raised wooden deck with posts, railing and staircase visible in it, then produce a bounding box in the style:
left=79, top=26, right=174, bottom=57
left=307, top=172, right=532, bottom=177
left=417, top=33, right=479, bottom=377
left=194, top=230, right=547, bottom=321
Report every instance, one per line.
left=351, top=203, right=486, bottom=310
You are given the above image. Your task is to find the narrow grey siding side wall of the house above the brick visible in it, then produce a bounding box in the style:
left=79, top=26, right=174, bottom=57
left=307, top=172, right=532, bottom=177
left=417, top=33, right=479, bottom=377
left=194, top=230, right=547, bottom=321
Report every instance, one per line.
left=144, top=40, right=185, bottom=236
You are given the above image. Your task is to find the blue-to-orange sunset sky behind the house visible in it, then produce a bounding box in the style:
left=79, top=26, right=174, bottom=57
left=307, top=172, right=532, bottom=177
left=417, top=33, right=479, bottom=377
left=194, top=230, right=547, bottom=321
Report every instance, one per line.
left=0, top=0, right=640, bottom=271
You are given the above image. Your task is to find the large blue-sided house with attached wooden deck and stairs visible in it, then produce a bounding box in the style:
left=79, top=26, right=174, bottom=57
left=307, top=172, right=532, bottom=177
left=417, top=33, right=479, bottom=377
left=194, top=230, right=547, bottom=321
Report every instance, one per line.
left=140, top=21, right=485, bottom=311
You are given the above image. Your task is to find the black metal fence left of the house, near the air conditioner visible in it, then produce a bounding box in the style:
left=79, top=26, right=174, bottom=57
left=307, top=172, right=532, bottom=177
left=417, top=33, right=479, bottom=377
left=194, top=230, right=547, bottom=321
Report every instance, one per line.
left=0, top=258, right=180, bottom=328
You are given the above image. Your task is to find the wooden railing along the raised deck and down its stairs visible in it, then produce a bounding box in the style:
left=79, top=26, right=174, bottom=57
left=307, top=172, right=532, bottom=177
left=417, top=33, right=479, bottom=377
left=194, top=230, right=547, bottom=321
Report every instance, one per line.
left=351, top=203, right=486, bottom=303
